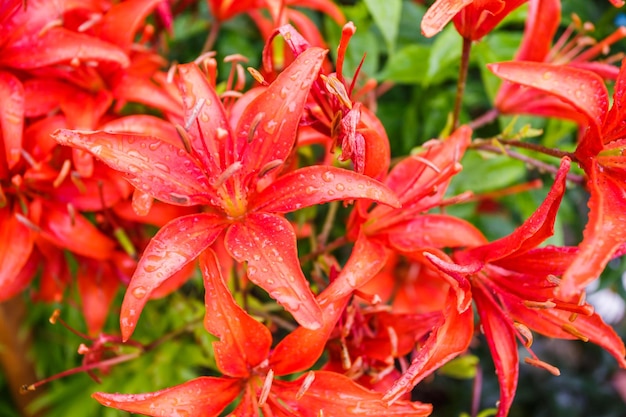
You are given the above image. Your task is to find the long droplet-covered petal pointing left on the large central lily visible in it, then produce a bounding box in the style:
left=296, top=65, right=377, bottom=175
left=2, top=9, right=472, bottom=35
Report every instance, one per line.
left=53, top=129, right=216, bottom=206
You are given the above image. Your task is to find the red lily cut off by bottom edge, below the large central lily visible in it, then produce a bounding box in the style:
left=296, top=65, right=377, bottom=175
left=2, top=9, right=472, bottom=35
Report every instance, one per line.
left=94, top=244, right=431, bottom=417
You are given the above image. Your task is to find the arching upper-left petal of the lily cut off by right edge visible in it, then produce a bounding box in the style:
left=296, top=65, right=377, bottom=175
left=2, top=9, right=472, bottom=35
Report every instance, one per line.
left=487, top=62, right=609, bottom=132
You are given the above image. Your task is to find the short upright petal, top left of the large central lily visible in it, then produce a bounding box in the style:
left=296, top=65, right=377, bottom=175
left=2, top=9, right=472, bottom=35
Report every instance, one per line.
left=178, top=64, right=232, bottom=177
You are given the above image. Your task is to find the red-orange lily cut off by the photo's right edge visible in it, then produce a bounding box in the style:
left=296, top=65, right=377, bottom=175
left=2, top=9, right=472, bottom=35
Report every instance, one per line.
left=490, top=57, right=626, bottom=297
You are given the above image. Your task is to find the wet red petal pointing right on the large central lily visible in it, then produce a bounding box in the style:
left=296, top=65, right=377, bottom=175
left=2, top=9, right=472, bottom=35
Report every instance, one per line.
left=251, top=165, right=400, bottom=213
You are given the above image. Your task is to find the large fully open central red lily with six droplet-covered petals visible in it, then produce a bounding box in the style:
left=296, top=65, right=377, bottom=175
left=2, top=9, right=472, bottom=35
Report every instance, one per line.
left=55, top=48, right=397, bottom=339
